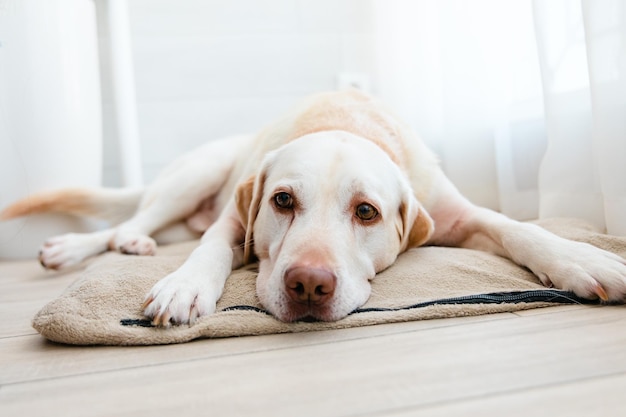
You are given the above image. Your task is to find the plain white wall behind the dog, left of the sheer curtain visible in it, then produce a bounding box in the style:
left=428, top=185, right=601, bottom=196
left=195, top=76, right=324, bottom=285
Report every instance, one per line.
left=99, top=0, right=376, bottom=186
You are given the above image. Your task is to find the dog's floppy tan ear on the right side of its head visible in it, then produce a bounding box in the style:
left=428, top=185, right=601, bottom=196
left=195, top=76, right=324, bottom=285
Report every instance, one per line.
left=398, top=192, right=435, bottom=252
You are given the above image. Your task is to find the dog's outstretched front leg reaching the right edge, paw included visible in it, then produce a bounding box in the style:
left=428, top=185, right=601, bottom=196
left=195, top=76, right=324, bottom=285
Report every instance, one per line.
left=429, top=176, right=626, bottom=302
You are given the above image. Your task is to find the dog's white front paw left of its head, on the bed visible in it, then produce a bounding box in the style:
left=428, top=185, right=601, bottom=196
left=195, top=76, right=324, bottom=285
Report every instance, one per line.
left=142, top=271, right=219, bottom=327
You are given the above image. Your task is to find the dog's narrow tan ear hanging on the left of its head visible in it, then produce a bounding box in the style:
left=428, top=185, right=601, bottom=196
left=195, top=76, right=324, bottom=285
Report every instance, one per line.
left=235, top=172, right=265, bottom=264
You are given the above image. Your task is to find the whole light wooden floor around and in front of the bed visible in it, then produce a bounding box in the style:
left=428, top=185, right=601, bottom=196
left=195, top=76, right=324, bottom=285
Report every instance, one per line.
left=0, top=262, right=626, bottom=417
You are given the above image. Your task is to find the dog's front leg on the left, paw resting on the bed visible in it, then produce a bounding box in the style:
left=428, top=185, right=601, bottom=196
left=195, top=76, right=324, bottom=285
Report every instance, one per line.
left=143, top=202, right=245, bottom=326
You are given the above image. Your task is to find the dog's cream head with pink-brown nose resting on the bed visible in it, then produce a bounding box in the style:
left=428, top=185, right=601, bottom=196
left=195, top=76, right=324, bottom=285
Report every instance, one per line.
left=237, top=131, right=433, bottom=321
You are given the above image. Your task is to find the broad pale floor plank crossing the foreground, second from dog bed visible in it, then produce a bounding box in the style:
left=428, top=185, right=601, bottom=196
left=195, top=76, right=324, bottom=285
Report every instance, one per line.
left=0, top=307, right=626, bottom=416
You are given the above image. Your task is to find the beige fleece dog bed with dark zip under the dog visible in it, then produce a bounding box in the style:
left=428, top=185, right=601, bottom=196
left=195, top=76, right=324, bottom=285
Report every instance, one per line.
left=33, top=219, right=626, bottom=345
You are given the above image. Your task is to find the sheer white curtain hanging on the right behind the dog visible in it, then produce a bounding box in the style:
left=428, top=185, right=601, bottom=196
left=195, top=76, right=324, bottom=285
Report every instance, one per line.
left=374, top=0, right=626, bottom=235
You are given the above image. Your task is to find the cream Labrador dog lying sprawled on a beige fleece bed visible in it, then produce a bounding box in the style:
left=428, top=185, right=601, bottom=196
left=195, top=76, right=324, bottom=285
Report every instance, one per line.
left=0, top=90, right=626, bottom=326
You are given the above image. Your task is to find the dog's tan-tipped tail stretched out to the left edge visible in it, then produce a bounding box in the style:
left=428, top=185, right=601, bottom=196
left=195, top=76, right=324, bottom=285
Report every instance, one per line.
left=0, top=188, right=143, bottom=224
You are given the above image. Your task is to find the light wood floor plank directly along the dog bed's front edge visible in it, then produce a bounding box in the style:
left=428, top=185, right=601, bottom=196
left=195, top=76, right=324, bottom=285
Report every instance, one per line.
left=0, top=313, right=516, bottom=384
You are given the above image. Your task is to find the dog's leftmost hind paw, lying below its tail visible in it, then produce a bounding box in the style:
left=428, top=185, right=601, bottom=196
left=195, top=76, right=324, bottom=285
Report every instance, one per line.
left=38, top=233, right=104, bottom=269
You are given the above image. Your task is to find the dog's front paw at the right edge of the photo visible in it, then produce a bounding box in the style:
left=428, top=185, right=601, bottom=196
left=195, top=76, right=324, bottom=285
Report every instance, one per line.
left=531, top=240, right=626, bottom=302
